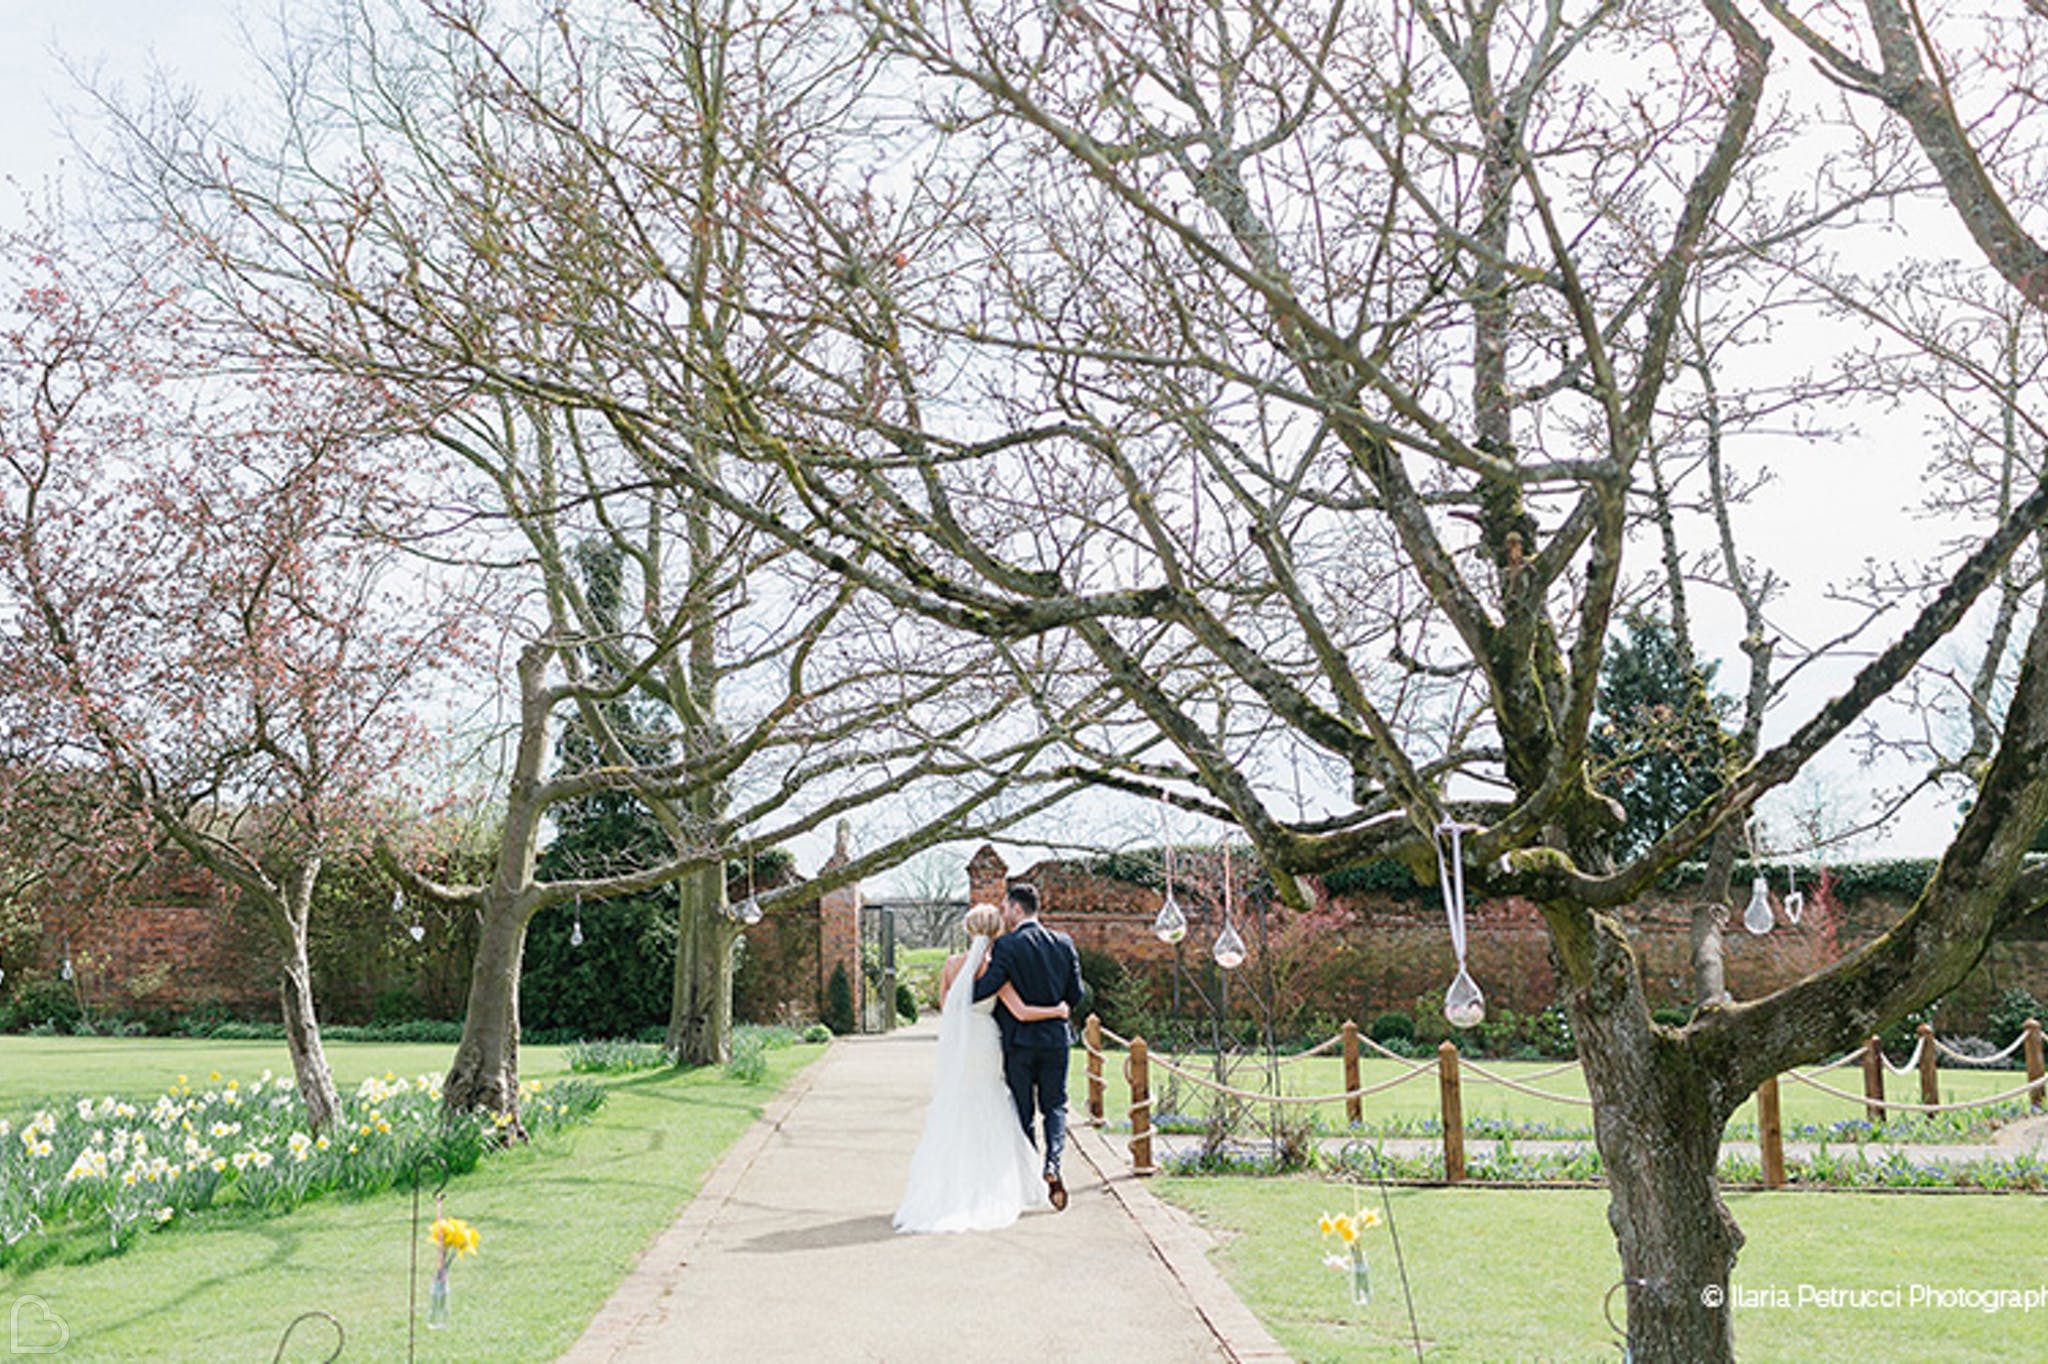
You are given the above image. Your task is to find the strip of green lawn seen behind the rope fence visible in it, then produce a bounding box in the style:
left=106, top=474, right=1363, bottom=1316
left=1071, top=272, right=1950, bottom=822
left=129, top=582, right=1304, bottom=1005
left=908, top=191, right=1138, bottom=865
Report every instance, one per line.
left=1069, top=1049, right=2048, bottom=1138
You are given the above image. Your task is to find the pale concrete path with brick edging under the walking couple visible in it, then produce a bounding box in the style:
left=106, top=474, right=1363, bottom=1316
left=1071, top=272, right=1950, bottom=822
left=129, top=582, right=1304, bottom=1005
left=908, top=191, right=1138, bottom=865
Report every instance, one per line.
left=563, top=1020, right=1286, bottom=1364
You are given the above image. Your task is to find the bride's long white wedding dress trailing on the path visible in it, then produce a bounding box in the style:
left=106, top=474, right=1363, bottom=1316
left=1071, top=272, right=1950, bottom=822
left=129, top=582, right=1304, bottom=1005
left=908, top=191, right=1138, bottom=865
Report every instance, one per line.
left=895, top=938, right=1047, bottom=1231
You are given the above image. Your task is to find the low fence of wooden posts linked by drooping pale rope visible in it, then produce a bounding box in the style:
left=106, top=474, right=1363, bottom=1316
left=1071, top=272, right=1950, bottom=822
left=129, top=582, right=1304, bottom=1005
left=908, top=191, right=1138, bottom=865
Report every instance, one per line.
left=1081, top=1014, right=2048, bottom=1188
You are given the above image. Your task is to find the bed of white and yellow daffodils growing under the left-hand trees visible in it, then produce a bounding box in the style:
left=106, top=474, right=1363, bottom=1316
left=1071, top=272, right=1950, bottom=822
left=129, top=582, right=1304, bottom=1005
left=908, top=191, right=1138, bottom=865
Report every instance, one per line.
left=0, top=1071, right=604, bottom=1266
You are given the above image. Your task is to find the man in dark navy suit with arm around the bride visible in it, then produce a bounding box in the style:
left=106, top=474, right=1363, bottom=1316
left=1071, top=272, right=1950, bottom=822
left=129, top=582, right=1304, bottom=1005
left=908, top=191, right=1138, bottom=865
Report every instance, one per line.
left=975, top=885, right=1081, bottom=1210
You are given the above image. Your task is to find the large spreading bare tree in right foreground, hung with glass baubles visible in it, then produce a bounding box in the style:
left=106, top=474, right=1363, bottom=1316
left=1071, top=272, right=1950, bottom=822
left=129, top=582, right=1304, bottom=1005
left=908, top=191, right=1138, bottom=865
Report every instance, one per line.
left=460, top=2, right=2048, bottom=1362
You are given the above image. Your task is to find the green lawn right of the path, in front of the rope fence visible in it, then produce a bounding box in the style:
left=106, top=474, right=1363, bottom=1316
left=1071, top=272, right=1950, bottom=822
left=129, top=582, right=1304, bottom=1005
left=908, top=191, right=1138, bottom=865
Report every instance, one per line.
left=1149, top=1178, right=2048, bottom=1364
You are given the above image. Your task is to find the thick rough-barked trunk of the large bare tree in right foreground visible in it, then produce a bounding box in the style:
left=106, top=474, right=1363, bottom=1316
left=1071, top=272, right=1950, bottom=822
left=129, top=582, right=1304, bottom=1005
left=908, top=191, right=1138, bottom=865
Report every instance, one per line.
left=1569, top=901, right=1743, bottom=1364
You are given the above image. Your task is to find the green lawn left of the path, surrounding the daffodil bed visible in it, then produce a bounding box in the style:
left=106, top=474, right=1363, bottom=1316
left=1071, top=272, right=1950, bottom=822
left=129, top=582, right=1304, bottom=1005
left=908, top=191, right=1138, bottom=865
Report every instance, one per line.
left=0, top=1038, right=823, bottom=1364
